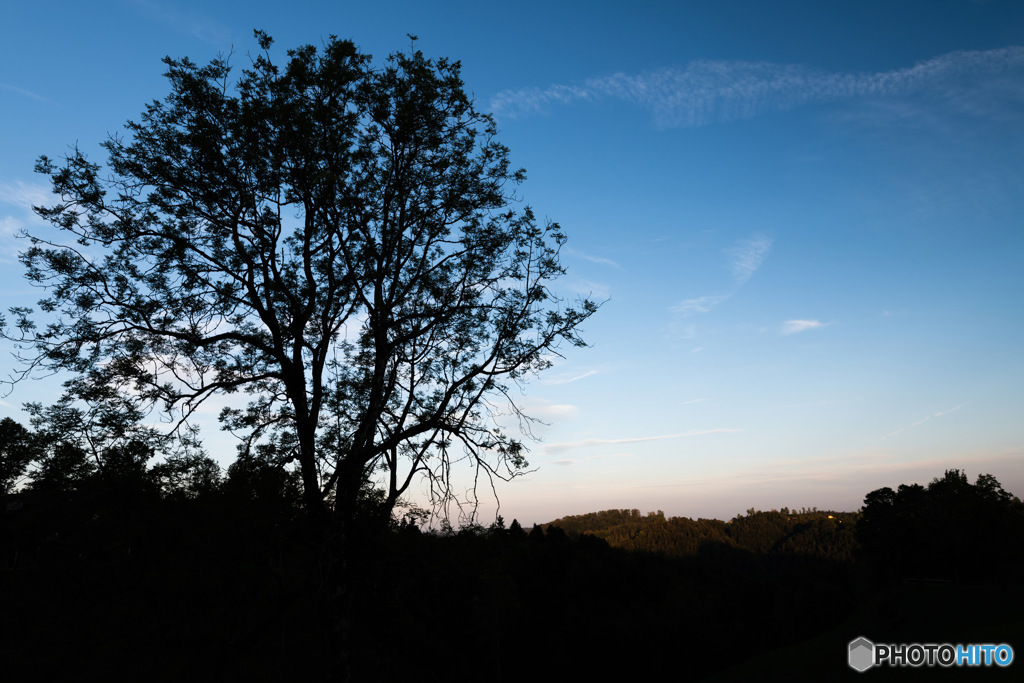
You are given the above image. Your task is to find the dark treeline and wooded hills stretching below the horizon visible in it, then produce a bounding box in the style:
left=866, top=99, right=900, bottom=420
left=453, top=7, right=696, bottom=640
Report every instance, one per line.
left=0, top=413, right=1024, bottom=681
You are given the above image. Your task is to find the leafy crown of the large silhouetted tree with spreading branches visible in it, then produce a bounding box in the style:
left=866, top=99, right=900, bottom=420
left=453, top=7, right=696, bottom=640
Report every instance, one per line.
left=4, top=32, right=597, bottom=515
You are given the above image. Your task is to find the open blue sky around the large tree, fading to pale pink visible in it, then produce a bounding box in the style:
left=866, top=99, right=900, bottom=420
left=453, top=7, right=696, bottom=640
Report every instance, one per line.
left=0, top=0, right=1024, bottom=523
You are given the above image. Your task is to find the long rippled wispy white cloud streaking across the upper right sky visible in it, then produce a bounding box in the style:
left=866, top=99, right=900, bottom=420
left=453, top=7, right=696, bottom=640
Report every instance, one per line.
left=490, top=46, right=1024, bottom=128
